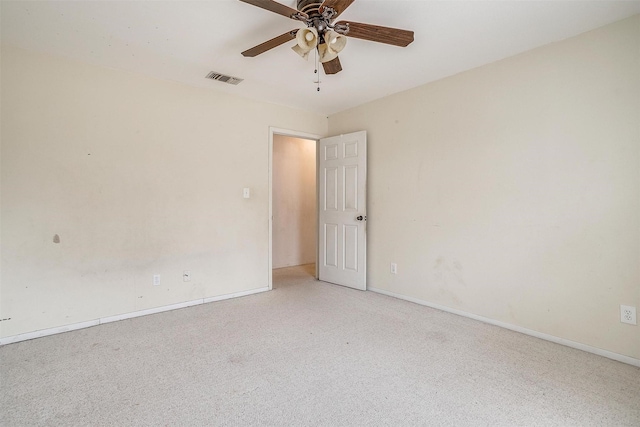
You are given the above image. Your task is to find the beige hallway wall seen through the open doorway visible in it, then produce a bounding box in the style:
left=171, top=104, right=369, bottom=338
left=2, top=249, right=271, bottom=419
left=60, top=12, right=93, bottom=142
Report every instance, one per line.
left=272, top=135, right=317, bottom=268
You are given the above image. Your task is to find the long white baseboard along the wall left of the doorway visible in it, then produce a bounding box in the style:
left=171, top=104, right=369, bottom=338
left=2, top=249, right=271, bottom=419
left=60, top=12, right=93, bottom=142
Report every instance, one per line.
left=0, top=287, right=269, bottom=346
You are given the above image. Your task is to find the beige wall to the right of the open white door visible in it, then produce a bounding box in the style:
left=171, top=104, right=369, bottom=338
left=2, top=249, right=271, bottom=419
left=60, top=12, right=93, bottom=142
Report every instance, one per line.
left=329, top=16, right=640, bottom=358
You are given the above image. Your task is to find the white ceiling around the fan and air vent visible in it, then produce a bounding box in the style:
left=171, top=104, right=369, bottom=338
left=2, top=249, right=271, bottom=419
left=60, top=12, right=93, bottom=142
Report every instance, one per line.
left=0, top=0, right=640, bottom=114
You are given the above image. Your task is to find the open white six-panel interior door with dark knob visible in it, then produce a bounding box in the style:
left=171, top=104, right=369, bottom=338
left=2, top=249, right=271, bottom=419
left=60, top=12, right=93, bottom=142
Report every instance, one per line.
left=318, top=131, right=367, bottom=290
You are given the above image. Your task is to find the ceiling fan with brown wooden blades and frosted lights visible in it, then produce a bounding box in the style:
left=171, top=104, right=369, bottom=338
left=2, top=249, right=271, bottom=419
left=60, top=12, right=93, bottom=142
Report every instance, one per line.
left=240, top=0, right=413, bottom=74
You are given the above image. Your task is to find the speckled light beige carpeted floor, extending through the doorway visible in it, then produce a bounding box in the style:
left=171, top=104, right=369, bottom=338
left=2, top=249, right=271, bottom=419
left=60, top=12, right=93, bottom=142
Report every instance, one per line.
left=0, top=266, right=640, bottom=427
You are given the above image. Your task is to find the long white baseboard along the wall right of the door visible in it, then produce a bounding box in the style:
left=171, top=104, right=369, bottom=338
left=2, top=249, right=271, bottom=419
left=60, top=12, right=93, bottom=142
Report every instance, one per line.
left=367, top=288, right=640, bottom=367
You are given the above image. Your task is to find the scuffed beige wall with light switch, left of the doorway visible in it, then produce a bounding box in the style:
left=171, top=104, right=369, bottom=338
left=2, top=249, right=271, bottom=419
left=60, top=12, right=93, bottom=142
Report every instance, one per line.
left=0, top=46, right=327, bottom=336
